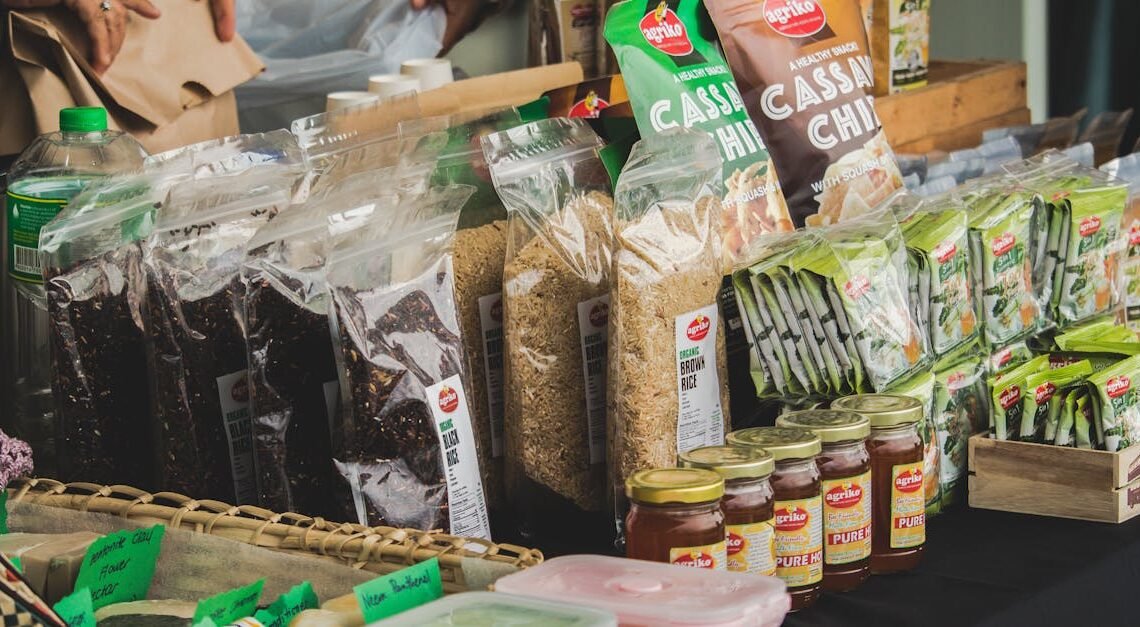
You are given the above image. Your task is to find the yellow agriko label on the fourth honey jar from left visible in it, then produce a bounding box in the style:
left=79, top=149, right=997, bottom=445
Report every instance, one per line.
left=822, top=471, right=872, bottom=564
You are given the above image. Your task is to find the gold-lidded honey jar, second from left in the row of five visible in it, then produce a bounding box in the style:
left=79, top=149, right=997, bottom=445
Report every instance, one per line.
left=678, top=446, right=776, bottom=575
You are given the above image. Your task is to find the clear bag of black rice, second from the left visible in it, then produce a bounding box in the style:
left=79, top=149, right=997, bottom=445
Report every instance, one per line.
left=143, top=166, right=300, bottom=504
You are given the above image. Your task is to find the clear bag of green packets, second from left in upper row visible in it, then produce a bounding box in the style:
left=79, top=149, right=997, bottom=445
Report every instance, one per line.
left=903, top=210, right=978, bottom=357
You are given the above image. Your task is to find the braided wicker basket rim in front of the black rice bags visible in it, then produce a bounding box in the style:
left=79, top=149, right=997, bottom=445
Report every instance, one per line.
left=8, top=479, right=543, bottom=593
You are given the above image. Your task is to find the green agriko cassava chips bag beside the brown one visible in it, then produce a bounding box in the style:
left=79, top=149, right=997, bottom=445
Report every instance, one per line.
left=604, top=0, right=793, bottom=266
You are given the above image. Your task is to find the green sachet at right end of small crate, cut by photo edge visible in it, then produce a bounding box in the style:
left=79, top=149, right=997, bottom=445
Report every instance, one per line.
left=1089, top=356, right=1140, bottom=451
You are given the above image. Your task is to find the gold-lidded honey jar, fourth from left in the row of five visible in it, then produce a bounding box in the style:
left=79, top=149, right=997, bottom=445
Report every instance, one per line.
left=776, top=409, right=873, bottom=592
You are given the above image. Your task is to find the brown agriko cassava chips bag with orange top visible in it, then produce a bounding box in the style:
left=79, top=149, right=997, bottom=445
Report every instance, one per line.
left=707, top=0, right=903, bottom=227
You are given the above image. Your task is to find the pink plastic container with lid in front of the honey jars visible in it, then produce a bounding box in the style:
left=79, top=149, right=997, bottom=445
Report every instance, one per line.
left=495, top=555, right=791, bottom=627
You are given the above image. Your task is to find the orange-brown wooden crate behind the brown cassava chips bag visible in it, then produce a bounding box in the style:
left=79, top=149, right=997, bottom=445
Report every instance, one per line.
left=874, top=60, right=1029, bottom=154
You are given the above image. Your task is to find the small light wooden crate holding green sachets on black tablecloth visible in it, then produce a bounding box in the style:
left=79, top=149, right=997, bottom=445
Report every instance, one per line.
left=969, top=433, right=1140, bottom=522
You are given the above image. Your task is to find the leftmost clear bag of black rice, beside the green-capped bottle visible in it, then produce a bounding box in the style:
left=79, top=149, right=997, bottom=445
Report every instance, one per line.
left=40, top=174, right=172, bottom=490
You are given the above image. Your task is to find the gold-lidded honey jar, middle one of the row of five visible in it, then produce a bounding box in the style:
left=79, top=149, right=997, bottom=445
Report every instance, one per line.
left=726, top=426, right=823, bottom=610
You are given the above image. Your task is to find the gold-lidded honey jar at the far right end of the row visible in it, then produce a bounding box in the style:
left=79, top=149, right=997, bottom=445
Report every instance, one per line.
left=831, top=394, right=926, bottom=573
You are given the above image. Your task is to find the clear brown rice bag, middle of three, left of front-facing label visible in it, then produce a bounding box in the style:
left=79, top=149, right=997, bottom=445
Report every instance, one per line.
left=483, top=119, right=613, bottom=540
